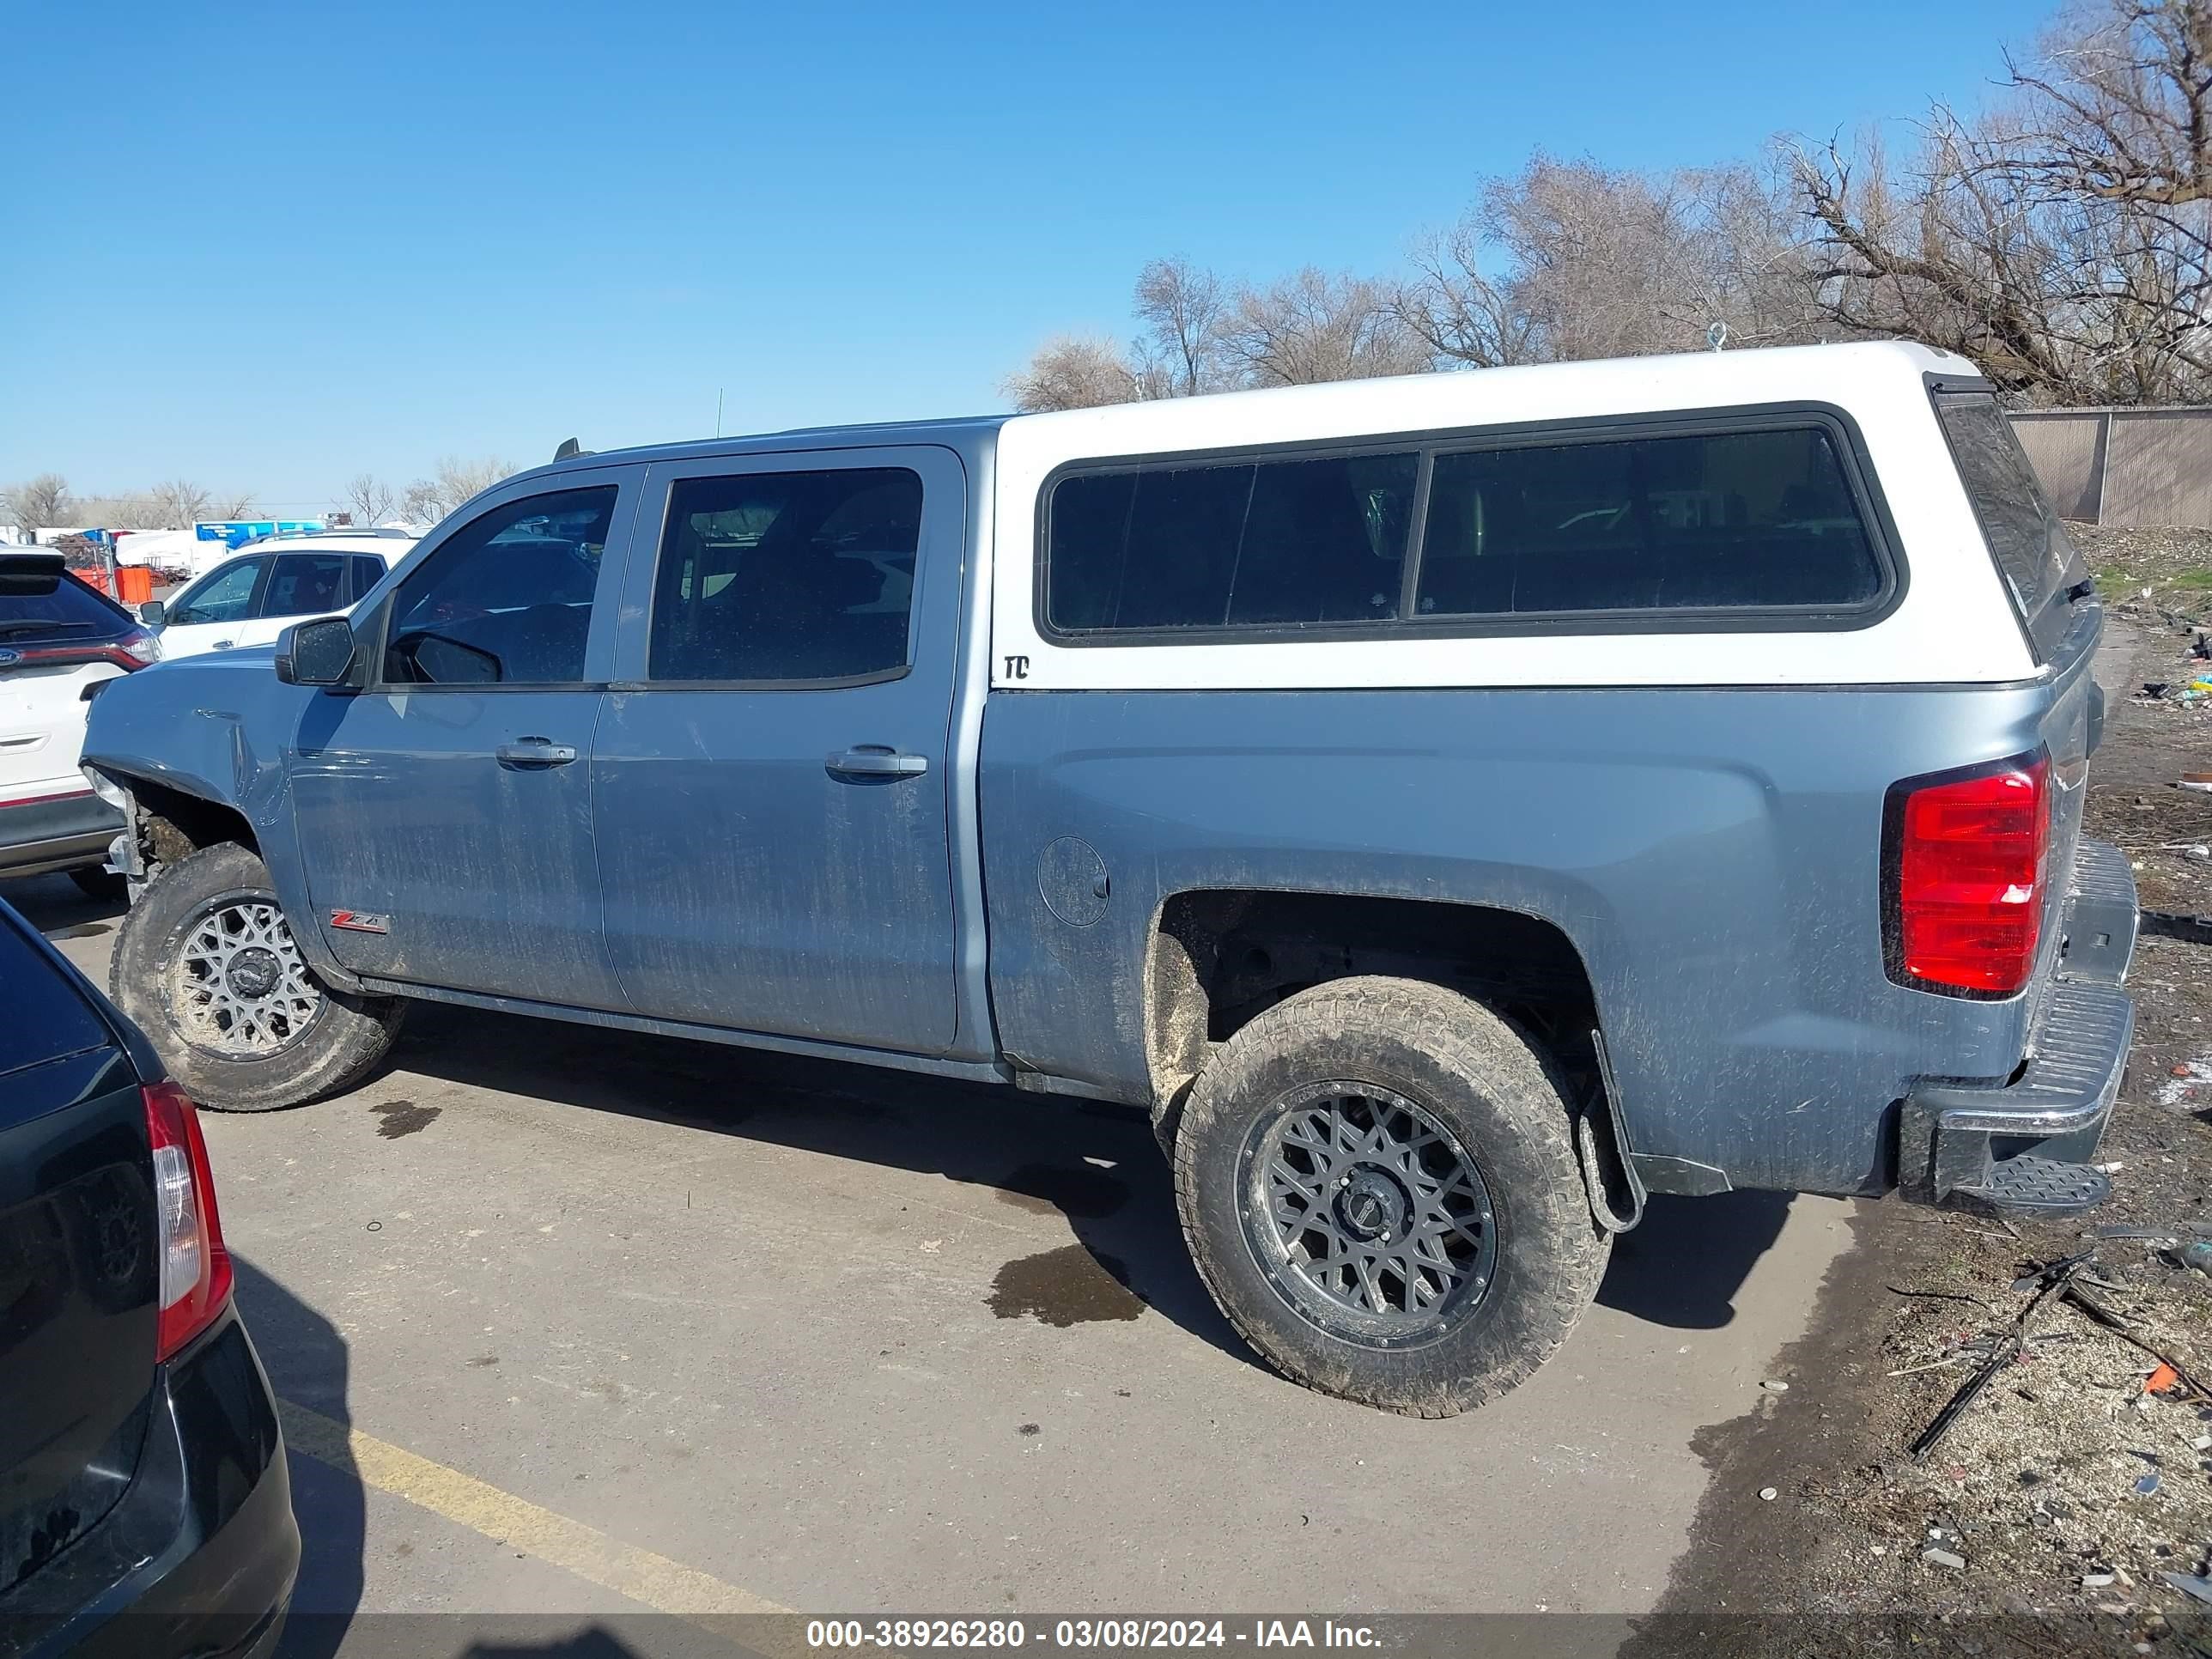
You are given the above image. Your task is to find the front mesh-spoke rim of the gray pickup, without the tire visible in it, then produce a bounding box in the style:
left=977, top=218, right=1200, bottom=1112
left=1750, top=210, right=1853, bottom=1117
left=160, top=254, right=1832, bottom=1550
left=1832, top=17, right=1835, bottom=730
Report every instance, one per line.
left=168, top=898, right=325, bottom=1060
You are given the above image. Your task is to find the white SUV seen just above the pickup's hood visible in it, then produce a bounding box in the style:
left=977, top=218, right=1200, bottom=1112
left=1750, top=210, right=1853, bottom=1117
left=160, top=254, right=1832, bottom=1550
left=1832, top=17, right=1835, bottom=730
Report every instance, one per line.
left=139, top=531, right=416, bottom=657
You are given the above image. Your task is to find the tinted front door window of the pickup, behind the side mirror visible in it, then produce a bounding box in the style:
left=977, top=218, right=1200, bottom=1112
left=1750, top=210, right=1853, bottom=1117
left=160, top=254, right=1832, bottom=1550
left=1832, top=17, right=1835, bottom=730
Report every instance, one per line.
left=385, top=484, right=619, bottom=686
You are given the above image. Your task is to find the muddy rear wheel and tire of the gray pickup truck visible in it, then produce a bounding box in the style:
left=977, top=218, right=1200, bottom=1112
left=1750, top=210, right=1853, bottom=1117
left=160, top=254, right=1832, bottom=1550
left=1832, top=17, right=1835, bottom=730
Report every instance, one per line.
left=1175, top=978, right=1610, bottom=1418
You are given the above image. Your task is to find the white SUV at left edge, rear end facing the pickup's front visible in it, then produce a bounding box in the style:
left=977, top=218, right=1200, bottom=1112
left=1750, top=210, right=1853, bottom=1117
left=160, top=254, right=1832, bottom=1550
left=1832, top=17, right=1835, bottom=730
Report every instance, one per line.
left=0, top=553, right=161, bottom=894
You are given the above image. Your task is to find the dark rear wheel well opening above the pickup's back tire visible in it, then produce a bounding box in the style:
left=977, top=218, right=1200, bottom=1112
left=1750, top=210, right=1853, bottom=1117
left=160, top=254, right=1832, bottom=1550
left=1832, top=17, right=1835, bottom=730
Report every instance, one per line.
left=1146, top=890, right=1597, bottom=1103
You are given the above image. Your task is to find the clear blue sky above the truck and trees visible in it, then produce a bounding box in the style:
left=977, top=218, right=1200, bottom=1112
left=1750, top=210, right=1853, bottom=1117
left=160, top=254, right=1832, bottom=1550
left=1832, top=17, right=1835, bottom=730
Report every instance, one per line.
left=0, top=0, right=2048, bottom=511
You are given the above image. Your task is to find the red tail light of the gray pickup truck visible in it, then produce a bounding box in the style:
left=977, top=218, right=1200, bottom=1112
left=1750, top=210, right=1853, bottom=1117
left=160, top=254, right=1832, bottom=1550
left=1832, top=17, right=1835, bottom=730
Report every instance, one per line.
left=1885, top=754, right=2051, bottom=998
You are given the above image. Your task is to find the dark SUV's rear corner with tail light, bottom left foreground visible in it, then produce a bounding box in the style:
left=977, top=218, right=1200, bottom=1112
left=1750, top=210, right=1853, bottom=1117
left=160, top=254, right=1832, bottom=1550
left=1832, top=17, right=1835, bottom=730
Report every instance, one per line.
left=0, top=902, right=299, bottom=1659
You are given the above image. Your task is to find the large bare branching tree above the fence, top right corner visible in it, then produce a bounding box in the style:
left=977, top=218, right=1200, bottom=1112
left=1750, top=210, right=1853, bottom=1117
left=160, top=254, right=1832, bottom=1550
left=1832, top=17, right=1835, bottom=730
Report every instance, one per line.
left=1794, top=0, right=2212, bottom=403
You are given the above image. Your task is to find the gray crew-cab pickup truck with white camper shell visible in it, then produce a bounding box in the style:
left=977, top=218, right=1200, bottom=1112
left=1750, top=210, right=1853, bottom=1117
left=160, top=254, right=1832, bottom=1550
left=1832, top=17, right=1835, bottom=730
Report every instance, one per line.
left=84, top=345, right=2135, bottom=1416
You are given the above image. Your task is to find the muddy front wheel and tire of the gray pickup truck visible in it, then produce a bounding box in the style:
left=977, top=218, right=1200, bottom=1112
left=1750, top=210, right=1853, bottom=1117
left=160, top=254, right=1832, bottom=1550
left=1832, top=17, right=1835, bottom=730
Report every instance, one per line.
left=108, top=841, right=407, bottom=1113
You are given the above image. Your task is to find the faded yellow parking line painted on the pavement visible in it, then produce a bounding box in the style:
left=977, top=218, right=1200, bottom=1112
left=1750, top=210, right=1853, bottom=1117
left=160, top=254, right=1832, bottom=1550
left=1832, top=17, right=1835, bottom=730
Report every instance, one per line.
left=276, top=1401, right=790, bottom=1620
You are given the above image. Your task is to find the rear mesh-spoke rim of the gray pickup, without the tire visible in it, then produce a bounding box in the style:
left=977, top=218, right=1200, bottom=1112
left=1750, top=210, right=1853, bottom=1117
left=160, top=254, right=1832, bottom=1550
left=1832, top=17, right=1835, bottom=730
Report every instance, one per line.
left=1243, top=1082, right=1498, bottom=1347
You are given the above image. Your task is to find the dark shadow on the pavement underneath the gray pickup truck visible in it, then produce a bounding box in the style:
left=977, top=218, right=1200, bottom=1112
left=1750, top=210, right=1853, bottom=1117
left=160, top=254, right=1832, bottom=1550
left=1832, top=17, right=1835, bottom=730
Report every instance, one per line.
left=389, top=1005, right=1790, bottom=1364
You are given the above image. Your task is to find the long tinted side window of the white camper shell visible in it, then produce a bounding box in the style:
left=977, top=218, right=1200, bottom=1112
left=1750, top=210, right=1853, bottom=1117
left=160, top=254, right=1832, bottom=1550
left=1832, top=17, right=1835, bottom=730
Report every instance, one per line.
left=1037, top=404, right=1902, bottom=644
